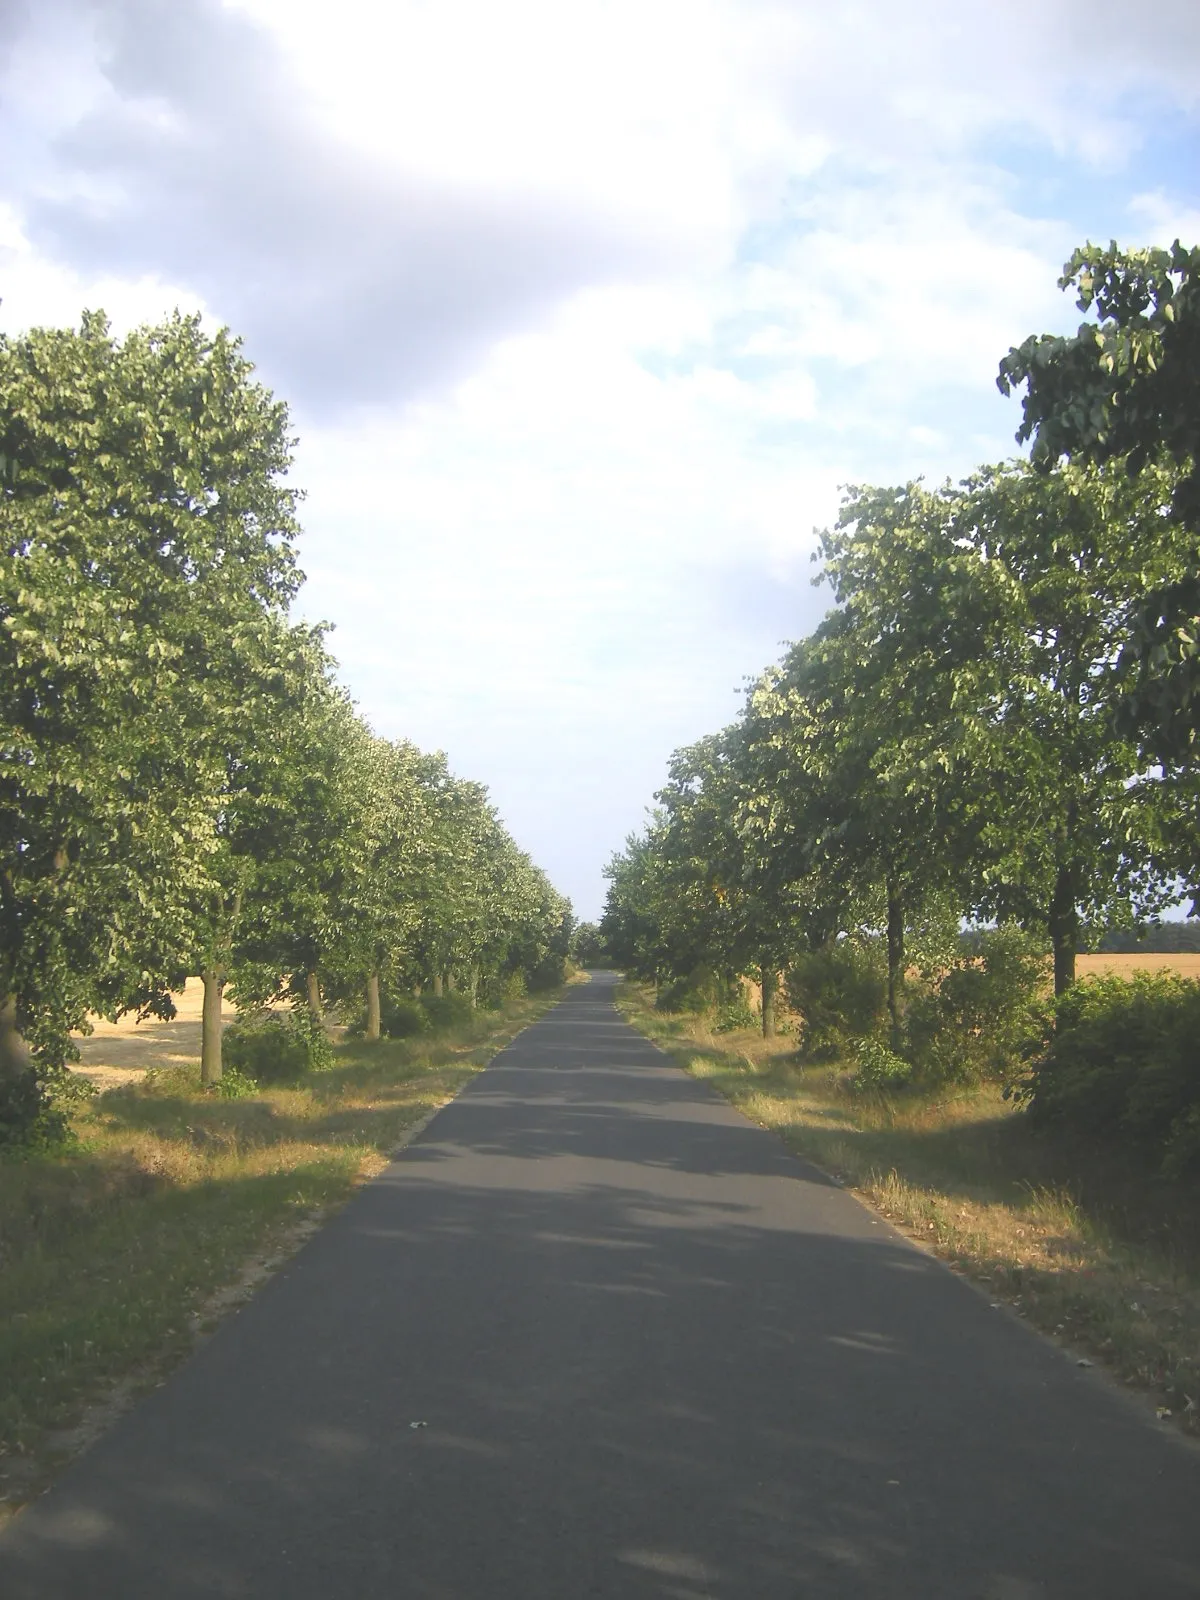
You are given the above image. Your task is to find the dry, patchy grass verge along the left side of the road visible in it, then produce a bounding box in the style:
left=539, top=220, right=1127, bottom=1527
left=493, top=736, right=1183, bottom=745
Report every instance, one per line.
left=0, top=992, right=560, bottom=1518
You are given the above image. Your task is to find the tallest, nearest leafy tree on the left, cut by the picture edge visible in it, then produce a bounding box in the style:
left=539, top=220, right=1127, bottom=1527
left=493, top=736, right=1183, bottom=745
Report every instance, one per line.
left=0, top=314, right=299, bottom=1126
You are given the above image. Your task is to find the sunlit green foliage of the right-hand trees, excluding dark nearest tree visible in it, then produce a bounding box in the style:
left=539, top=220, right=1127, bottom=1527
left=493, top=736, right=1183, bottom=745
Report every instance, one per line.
left=605, top=462, right=1200, bottom=1022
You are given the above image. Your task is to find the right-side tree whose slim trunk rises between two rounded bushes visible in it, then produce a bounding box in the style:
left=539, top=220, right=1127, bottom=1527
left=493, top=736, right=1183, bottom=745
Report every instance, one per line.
left=773, top=483, right=998, bottom=1043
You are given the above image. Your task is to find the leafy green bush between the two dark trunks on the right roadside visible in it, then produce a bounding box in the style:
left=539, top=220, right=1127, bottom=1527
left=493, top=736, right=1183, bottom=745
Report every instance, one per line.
left=904, top=925, right=1046, bottom=1083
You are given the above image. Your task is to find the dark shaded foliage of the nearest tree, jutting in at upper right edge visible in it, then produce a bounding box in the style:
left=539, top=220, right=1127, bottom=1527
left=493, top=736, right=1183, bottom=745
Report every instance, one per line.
left=997, top=240, right=1200, bottom=762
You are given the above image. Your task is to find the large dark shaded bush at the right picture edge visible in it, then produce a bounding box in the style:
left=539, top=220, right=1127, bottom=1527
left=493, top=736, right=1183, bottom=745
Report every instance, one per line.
left=1021, top=973, right=1200, bottom=1176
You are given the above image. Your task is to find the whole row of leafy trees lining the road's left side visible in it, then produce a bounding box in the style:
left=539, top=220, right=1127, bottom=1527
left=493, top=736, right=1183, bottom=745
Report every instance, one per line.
left=0, top=315, right=570, bottom=1136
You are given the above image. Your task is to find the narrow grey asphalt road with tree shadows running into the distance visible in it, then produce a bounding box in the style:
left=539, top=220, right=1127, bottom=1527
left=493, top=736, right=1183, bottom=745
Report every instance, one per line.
left=0, top=978, right=1200, bottom=1600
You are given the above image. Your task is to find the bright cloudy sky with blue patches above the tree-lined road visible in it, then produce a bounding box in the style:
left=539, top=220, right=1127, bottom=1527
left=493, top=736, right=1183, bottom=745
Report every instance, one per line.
left=0, top=0, right=1200, bottom=918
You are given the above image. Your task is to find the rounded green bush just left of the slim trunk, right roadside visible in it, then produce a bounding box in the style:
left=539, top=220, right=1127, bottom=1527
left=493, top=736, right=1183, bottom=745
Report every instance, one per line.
left=784, top=936, right=888, bottom=1061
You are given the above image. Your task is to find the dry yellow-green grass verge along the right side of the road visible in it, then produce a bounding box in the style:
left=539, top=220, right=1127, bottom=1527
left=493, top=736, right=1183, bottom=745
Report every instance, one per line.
left=618, top=984, right=1200, bottom=1434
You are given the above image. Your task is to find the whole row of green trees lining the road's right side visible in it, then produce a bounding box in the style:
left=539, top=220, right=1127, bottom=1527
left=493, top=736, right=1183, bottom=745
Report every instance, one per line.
left=602, top=245, right=1200, bottom=1062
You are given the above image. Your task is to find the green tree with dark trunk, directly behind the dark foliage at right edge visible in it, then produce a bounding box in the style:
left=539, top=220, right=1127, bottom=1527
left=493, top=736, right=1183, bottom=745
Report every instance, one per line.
left=954, top=462, right=1190, bottom=994
